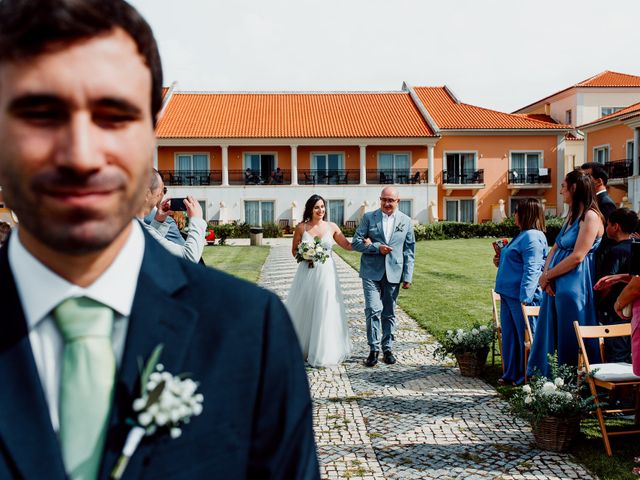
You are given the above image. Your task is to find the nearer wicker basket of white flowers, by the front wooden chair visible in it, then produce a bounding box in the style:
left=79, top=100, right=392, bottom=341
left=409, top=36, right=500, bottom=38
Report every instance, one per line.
left=509, top=355, right=594, bottom=452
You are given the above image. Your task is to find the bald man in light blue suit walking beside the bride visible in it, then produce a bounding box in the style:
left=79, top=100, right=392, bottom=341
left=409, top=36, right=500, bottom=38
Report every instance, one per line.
left=352, top=187, right=415, bottom=367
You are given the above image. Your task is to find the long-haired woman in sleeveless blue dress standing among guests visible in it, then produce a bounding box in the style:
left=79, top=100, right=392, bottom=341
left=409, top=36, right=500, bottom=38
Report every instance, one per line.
left=527, top=170, right=604, bottom=377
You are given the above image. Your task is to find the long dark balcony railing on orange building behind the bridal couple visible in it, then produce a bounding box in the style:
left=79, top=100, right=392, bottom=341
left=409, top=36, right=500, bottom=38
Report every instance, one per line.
left=159, top=169, right=430, bottom=186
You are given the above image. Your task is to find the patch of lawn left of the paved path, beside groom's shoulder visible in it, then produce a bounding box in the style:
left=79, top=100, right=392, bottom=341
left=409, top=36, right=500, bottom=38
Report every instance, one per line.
left=202, top=245, right=269, bottom=283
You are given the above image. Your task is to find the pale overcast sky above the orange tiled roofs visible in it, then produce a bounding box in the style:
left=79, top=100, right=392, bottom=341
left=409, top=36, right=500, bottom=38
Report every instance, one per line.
left=130, top=0, right=640, bottom=112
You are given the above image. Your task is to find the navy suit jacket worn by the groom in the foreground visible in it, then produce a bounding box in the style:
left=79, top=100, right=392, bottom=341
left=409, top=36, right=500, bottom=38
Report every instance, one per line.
left=0, top=234, right=319, bottom=480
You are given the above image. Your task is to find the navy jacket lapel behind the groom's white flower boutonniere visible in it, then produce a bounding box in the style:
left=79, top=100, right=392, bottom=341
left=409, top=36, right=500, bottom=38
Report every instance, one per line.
left=99, top=237, right=198, bottom=478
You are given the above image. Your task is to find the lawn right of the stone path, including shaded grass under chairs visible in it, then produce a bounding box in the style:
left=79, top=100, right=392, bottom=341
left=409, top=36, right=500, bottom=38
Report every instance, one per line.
left=336, top=239, right=640, bottom=480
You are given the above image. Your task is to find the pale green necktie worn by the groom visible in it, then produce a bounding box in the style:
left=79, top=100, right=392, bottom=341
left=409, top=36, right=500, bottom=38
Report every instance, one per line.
left=53, top=297, right=116, bottom=480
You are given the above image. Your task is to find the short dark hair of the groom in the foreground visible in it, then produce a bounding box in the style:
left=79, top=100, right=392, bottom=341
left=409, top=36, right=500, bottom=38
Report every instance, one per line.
left=0, top=0, right=162, bottom=126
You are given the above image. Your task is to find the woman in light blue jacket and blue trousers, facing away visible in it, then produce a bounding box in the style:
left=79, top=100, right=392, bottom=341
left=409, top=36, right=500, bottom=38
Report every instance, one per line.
left=495, top=198, right=548, bottom=385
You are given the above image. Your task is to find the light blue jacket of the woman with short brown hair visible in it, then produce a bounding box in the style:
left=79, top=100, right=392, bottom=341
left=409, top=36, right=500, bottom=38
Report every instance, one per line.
left=495, top=229, right=549, bottom=304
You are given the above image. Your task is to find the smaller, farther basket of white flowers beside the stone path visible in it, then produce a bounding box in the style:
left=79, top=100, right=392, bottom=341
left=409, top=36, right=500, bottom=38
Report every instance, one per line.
left=434, top=323, right=493, bottom=377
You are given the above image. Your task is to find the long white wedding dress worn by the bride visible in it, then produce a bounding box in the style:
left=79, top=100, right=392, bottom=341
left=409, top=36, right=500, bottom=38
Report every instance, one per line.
left=286, top=230, right=351, bottom=367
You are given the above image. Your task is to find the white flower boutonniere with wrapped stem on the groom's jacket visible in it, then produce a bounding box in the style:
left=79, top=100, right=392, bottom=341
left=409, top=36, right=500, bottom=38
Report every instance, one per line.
left=111, top=345, right=204, bottom=480
